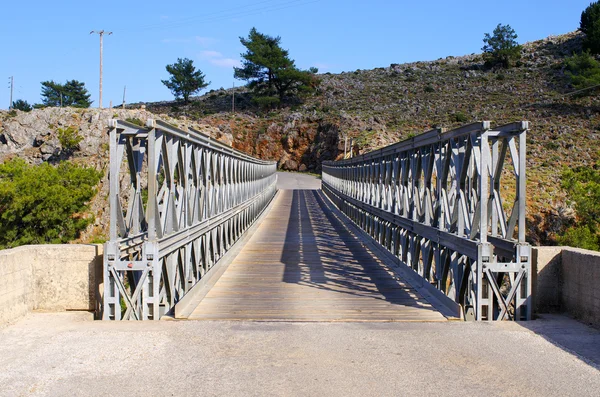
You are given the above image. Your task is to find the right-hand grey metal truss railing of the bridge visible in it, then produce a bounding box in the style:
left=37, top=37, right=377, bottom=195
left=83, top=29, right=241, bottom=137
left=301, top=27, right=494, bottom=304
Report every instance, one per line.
left=323, top=122, right=532, bottom=320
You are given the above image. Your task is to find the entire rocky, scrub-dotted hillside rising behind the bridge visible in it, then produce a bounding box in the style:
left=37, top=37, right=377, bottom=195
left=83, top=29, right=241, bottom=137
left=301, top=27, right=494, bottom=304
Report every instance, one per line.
left=0, top=33, right=600, bottom=244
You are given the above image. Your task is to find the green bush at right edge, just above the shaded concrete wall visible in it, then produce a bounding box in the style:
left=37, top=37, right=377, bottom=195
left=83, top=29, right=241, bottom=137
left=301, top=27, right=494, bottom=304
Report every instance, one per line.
left=558, top=163, right=600, bottom=250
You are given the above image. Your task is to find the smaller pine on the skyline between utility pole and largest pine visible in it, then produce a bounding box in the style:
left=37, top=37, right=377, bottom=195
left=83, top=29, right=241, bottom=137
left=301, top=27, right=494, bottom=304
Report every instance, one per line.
left=161, top=58, right=210, bottom=103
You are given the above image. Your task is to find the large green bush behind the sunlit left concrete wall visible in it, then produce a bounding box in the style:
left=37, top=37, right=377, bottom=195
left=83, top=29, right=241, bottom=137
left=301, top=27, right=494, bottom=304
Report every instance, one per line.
left=0, top=159, right=101, bottom=249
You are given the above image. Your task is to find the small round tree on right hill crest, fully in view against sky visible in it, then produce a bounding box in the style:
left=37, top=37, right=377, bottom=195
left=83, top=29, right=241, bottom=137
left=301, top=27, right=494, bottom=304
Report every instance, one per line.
left=481, top=24, right=522, bottom=68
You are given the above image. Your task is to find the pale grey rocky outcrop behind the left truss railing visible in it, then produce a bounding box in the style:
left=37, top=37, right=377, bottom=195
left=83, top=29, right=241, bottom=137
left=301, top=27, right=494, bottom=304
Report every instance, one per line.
left=0, top=108, right=238, bottom=242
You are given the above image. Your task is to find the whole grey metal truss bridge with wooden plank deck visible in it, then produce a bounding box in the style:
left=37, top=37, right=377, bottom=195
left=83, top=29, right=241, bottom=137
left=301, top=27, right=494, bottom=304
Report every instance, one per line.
left=103, top=120, right=532, bottom=321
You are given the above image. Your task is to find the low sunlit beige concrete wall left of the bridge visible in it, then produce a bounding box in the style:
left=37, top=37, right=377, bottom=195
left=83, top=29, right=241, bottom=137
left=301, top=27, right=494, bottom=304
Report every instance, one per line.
left=0, top=244, right=102, bottom=324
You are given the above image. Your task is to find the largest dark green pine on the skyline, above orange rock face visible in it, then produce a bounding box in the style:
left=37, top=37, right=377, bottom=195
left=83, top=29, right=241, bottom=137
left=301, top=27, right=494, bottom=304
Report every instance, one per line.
left=234, top=28, right=318, bottom=105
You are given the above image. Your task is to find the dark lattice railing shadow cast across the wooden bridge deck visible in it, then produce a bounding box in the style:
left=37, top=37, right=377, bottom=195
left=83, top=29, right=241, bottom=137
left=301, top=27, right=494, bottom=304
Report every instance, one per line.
left=281, top=190, right=434, bottom=310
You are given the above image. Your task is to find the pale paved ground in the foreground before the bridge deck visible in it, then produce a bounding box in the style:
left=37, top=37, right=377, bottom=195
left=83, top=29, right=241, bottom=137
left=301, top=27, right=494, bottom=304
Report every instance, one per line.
left=0, top=313, right=600, bottom=396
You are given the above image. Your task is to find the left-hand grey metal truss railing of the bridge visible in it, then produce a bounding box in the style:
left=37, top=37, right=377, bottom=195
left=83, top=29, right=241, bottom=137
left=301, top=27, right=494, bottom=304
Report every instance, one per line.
left=103, top=120, right=277, bottom=320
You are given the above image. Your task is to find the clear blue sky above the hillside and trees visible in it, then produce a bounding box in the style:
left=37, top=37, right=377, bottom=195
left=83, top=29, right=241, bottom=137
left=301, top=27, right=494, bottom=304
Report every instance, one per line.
left=0, top=0, right=590, bottom=109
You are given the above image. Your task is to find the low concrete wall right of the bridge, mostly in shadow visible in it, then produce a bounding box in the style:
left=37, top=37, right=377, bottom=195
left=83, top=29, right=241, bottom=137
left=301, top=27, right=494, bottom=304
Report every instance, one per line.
left=533, top=247, right=600, bottom=327
